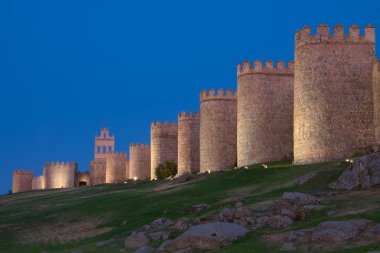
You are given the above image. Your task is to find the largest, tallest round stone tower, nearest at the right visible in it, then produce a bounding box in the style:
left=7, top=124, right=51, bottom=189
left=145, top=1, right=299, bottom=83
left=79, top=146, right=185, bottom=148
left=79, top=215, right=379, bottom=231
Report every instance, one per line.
left=294, top=24, right=375, bottom=164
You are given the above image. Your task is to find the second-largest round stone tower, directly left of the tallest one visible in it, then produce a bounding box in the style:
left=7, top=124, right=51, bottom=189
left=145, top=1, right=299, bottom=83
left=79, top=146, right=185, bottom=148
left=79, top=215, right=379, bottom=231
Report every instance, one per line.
left=237, top=61, right=294, bottom=167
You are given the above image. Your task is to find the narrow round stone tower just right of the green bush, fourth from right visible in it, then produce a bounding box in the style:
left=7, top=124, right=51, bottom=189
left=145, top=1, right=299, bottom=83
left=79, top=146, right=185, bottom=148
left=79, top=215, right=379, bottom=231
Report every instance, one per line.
left=178, top=112, right=200, bottom=175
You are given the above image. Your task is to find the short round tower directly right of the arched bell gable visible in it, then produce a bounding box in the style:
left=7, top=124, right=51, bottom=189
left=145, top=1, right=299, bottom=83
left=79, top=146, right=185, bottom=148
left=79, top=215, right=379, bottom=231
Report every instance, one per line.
left=106, top=152, right=129, bottom=184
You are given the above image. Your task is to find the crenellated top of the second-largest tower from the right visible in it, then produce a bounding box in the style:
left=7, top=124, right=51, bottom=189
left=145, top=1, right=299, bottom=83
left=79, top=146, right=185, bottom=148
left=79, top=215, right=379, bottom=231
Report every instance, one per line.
left=237, top=60, right=294, bottom=77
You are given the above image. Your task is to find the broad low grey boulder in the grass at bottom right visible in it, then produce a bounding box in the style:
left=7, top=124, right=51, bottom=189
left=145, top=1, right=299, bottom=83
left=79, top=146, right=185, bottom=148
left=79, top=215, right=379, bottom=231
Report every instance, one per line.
left=311, top=220, right=371, bottom=242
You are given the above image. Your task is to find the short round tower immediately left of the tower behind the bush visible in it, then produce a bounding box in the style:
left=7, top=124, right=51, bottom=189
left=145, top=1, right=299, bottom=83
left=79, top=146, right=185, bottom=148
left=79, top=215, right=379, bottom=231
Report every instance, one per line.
left=129, top=144, right=150, bottom=179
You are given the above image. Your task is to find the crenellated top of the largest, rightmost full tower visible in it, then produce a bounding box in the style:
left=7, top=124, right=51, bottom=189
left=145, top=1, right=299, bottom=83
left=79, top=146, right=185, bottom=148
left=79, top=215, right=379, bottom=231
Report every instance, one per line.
left=295, top=24, right=375, bottom=47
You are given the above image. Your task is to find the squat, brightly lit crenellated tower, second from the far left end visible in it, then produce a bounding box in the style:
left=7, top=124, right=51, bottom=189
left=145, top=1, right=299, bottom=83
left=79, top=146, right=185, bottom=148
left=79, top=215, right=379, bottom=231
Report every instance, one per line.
left=43, top=162, right=78, bottom=189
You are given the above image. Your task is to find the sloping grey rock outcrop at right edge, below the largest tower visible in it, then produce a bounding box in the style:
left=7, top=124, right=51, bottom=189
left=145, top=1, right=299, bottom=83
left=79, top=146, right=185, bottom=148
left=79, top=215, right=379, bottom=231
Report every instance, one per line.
left=329, top=152, right=380, bottom=190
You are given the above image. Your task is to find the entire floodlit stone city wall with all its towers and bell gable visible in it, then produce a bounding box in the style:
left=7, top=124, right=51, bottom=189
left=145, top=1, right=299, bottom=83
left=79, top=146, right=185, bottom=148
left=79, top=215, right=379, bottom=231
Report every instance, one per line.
left=12, top=24, right=380, bottom=193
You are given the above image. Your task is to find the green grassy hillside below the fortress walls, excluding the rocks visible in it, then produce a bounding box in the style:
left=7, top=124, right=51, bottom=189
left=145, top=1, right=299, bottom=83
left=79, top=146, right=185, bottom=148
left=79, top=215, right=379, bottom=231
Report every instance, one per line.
left=0, top=162, right=380, bottom=253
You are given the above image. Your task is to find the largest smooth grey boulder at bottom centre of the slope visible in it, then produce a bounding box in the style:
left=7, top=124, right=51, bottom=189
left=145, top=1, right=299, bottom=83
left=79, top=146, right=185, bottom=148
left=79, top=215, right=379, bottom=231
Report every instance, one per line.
left=160, top=222, right=249, bottom=253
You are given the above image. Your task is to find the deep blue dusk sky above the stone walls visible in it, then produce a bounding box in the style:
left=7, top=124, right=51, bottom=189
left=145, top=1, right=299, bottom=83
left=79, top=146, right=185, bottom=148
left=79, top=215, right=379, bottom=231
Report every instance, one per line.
left=0, top=0, right=380, bottom=194
